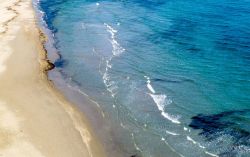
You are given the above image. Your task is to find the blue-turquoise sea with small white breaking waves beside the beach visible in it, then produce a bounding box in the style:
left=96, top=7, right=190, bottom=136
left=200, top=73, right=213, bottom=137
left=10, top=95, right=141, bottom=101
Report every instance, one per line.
left=35, top=0, right=250, bottom=157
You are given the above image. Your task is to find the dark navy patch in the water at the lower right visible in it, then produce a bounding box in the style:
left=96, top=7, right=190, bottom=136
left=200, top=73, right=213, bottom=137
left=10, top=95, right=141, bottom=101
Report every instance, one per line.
left=189, top=109, right=250, bottom=156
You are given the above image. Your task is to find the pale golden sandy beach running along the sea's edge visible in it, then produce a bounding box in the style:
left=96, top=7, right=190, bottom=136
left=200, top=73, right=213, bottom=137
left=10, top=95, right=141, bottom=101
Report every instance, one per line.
left=0, top=0, right=104, bottom=157
